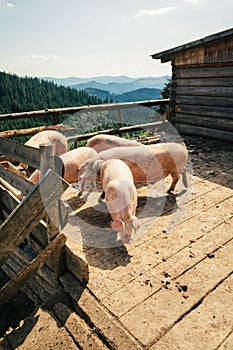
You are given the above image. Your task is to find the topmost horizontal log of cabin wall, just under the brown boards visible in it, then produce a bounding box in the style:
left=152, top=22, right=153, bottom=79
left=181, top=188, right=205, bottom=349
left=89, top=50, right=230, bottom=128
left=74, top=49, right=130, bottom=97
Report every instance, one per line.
left=174, top=65, right=233, bottom=79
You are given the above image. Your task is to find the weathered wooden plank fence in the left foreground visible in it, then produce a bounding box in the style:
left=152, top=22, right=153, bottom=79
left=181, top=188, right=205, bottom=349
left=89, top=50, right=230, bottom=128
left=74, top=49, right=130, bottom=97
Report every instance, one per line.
left=0, top=138, right=88, bottom=307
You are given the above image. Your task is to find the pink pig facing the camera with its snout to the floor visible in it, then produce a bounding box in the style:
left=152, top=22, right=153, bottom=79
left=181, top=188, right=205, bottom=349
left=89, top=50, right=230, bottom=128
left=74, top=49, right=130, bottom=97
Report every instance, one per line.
left=96, top=159, right=140, bottom=244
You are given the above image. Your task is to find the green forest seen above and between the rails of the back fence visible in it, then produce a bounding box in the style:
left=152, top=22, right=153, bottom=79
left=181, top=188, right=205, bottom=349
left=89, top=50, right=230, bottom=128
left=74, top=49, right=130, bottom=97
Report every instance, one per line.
left=0, top=72, right=168, bottom=142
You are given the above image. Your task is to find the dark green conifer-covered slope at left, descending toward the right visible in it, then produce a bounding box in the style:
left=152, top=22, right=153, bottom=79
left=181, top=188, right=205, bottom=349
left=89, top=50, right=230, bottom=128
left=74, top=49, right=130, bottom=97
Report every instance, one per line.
left=0, top=72, right=102, bottom=139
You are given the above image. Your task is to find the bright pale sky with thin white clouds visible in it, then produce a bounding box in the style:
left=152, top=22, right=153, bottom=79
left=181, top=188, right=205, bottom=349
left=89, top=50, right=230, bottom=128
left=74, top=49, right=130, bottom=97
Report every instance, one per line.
left=0, top=0, right=233, bottom=78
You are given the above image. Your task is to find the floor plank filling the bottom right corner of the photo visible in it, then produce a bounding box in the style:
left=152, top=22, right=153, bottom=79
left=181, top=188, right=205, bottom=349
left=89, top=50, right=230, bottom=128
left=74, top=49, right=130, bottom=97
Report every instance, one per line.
left=150, top=275, right=233, bottom=350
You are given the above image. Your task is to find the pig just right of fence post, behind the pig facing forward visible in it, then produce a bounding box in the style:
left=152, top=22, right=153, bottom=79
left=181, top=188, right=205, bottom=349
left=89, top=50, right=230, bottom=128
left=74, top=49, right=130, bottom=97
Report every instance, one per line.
left=29, top=147, right=97, bottom=184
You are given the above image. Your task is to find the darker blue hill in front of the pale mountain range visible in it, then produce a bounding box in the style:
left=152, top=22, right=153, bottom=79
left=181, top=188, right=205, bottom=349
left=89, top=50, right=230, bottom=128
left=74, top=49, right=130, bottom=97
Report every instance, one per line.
left=85, top=88, right=161, bottom=102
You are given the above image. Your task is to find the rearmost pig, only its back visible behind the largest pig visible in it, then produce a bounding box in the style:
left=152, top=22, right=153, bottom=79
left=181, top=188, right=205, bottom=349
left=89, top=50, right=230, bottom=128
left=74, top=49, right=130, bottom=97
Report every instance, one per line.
left=86, top=134, right=141, bottom=153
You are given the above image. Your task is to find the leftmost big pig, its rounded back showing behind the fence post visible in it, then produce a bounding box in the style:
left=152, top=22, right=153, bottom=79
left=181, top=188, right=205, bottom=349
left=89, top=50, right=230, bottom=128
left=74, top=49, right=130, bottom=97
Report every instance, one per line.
left=20, top=130, right=68, bottom=173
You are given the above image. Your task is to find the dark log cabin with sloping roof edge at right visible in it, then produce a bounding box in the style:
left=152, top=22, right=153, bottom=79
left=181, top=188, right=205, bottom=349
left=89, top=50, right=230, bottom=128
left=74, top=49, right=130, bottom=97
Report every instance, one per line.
left=152, top=30, right=233, bottom=142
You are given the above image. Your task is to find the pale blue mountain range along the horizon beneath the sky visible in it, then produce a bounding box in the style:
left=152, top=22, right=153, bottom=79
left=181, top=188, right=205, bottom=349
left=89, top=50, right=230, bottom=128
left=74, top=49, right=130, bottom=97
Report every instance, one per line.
left=43, top=75, right=169, bottom=94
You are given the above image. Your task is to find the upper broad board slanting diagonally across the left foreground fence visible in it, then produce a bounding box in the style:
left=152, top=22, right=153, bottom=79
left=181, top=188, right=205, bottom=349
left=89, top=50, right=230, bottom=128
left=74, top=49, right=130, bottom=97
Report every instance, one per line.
left=0, top=170, right=68, bottom=266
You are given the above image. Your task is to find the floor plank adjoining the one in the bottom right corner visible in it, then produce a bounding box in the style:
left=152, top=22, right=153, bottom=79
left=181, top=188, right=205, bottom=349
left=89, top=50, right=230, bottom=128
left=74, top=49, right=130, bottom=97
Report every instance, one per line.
left=120, top=240, right=233, bottom=346
